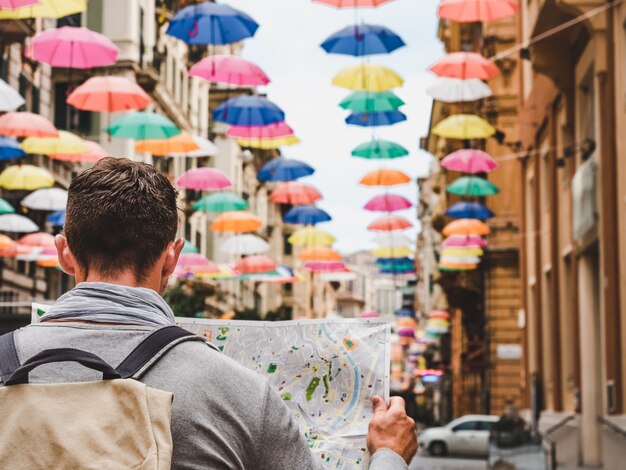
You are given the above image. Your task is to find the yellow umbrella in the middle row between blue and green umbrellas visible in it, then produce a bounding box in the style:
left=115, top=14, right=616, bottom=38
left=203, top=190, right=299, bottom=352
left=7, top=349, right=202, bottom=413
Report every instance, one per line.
left=333, top=64, right=404, bottom=92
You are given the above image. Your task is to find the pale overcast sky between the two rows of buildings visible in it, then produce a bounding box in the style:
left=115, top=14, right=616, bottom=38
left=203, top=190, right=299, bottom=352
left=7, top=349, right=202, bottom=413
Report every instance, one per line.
left=225, top=0, right=443, bottom=252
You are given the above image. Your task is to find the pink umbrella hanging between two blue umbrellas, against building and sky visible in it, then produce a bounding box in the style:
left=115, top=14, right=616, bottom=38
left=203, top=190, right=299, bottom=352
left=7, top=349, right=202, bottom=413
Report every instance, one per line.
left=189, top=55, right=270, bottom=86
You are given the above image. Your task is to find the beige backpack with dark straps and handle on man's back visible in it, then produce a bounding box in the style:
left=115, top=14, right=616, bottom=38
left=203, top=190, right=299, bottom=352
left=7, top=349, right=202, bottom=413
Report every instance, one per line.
left=0, top=326, right=202, bottom=470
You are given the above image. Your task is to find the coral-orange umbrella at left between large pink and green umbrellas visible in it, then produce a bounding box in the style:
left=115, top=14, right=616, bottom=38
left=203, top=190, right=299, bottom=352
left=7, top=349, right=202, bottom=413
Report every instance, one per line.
left=66, top=76, right=152, bottom=112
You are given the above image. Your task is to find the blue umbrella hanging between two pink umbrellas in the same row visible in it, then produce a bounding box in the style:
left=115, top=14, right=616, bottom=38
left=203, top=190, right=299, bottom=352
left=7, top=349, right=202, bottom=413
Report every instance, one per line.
left=213, top=96, right=285, bottom=126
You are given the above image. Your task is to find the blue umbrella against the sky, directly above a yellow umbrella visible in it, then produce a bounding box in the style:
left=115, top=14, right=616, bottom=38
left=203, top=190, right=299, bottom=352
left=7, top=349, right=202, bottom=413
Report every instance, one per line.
left=321, top=24, right=405, bottom=57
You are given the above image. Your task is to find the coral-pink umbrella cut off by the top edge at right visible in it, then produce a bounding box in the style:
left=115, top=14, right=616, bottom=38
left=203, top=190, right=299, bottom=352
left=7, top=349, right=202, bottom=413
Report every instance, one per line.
left=437, top=0, right=519, bottom=23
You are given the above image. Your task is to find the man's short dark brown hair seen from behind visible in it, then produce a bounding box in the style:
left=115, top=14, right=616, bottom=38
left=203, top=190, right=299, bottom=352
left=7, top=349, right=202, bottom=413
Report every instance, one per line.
left=65, top=157, right=178, bottom=281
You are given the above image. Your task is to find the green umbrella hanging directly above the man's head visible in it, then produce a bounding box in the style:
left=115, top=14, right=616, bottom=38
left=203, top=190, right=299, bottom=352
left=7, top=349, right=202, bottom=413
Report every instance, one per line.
left=107, top=111, right=180, bottom=140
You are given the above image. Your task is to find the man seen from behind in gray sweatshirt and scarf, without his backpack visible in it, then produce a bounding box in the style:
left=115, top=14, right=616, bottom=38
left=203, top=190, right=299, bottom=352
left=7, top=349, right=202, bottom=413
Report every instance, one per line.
left=6, top=158, right=417, bottom=470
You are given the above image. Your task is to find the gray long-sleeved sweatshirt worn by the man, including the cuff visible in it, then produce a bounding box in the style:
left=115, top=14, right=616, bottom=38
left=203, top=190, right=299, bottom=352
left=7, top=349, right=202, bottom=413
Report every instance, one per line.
left=7, top=322, right=408, bottom=470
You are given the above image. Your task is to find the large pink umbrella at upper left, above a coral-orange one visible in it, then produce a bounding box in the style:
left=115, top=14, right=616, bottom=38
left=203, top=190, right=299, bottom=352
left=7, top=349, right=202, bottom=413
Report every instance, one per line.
left=33, top=26, right=120, bottom=69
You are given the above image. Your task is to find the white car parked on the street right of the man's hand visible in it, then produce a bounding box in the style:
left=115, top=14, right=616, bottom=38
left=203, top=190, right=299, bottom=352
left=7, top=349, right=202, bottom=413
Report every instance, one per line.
left=419, top=415, right=500, bottom=456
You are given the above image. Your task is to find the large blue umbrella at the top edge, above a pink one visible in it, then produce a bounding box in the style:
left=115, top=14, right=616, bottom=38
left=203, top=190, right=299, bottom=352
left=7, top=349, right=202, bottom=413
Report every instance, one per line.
left=167, top=2, right=259, bottom=46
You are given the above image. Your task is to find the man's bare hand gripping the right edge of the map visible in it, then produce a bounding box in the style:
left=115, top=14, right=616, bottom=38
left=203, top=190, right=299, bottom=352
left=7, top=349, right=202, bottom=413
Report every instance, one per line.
left=367, top=396, right=417, bottom=464
